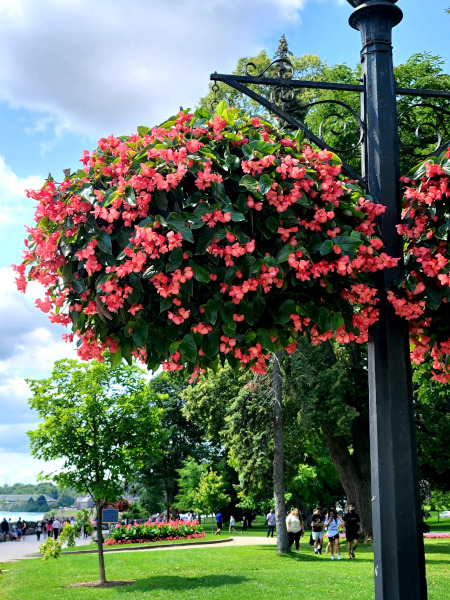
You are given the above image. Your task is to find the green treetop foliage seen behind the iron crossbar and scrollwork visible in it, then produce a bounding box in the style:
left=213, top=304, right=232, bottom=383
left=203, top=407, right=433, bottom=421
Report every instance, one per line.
left=200, top=50, right=450, bottom=173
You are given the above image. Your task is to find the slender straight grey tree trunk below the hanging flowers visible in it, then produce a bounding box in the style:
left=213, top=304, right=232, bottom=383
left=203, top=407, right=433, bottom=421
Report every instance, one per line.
left=273, top=350, right=289, bottom=554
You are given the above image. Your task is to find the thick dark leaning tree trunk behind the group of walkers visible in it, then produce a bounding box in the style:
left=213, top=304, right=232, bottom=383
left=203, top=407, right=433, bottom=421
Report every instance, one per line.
left=323, top=429, right=372, bottom=537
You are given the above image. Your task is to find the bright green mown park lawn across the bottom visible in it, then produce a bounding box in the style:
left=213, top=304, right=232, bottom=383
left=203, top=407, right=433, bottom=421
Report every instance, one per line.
left=0, top=540, right=450, bottom=600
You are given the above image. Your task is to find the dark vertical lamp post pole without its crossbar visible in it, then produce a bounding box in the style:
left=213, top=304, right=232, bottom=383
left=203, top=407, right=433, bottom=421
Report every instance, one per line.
left=349, top=0, right=427, bottom=600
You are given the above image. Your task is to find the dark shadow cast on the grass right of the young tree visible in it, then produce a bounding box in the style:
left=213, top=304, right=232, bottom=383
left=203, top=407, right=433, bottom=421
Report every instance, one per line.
left=116, top=575, right=248, bottom=594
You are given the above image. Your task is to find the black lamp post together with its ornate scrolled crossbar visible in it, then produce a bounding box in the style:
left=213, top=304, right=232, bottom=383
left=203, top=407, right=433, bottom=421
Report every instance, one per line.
left=211, top=0, right=450, bottom=600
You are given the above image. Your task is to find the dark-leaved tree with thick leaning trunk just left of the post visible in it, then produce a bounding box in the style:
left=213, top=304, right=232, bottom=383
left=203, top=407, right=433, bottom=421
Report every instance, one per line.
left=284, top=339, right=372, bottom=536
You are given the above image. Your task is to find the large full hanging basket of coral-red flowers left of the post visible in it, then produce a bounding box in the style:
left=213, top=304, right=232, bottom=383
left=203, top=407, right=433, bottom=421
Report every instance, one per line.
left=15, top=103, right=397, bottom=380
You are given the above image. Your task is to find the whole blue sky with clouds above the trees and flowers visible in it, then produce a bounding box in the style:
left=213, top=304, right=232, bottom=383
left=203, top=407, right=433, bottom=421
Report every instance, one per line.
left=0, top=0, right=450, bottom=484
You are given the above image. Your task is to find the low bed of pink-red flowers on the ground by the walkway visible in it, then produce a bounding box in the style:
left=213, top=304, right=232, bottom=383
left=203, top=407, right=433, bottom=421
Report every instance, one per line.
left=104, top=520, right=205, bottom=546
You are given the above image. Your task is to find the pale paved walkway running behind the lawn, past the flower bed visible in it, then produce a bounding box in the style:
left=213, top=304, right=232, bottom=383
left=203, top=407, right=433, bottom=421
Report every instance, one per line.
left=0, top=535, right=277, bottom=563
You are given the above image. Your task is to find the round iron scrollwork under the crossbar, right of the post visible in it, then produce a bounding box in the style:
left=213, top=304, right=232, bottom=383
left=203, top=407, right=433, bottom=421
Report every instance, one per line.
left=398, top=102, right=450, bottom=159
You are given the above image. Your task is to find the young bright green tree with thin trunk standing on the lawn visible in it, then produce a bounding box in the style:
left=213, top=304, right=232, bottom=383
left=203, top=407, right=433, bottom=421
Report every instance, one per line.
left=27, top=359, right=163, bottom=584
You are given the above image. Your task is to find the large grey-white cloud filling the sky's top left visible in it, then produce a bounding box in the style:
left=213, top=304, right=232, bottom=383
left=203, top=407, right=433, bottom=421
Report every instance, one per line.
left=0, top=0, right=307, bottom=136
